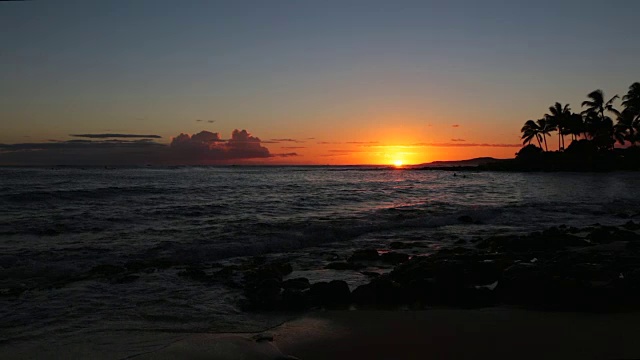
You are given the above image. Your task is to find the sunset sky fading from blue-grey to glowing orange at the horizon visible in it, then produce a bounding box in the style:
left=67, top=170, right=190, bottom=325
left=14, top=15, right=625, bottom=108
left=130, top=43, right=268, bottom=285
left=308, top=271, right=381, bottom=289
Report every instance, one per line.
left=0, top=0, right=640, bottom=165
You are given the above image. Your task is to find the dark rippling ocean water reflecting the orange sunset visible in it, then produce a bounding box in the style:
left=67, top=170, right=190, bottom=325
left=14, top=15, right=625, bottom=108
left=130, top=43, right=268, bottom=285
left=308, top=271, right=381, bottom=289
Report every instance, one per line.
left=0, top=166, right=640, bottom=358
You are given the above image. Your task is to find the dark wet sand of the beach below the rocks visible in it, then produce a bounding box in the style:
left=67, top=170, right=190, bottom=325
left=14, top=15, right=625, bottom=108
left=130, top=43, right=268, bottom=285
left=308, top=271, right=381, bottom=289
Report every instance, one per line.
left=126, top=308, right=640, bottom=360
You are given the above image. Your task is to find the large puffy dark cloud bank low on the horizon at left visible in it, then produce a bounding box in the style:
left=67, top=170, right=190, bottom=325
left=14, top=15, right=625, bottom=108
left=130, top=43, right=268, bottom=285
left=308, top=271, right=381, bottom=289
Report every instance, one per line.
left=0, top=130, right=278, bottom=165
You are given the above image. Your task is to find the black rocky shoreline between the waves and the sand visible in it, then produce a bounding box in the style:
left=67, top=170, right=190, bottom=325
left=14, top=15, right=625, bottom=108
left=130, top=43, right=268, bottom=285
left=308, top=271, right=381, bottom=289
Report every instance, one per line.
left=239, top=221, right=640, bottom=312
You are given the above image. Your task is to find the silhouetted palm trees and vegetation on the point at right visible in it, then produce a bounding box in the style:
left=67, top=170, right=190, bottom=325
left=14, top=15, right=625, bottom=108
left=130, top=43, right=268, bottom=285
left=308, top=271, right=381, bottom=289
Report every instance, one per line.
left=512, top=82, right=640, bottom=171
